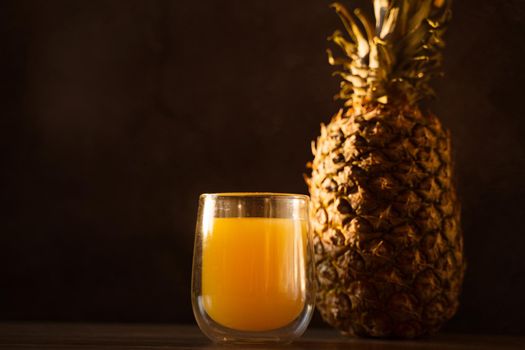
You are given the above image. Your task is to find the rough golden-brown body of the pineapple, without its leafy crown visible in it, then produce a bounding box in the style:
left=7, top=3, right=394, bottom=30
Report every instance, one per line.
left=308, top=105, right=465, bottom=338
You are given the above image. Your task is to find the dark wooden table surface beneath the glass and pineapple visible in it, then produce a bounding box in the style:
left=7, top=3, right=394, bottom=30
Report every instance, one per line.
left=0, top=323, right=525, bottom=350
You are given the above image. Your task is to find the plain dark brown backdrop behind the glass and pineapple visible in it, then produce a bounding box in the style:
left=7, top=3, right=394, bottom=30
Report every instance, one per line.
left=0, top=0, right=525, bottom=334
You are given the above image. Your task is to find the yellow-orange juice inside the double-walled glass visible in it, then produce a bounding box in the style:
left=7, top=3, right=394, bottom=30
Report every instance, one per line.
left=202, top=218, right=307, bottom=331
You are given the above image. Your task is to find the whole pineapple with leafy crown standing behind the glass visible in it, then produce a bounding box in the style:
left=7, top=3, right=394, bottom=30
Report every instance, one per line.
left=307, top=0, right=465, bottom=338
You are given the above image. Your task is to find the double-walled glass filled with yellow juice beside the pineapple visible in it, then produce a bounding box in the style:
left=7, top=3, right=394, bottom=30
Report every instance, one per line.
left=191, top=193, right=315, bottom=343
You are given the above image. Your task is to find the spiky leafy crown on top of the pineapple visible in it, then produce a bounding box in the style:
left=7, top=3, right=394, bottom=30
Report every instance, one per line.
left=328, top=0, right=451, bottom=107
